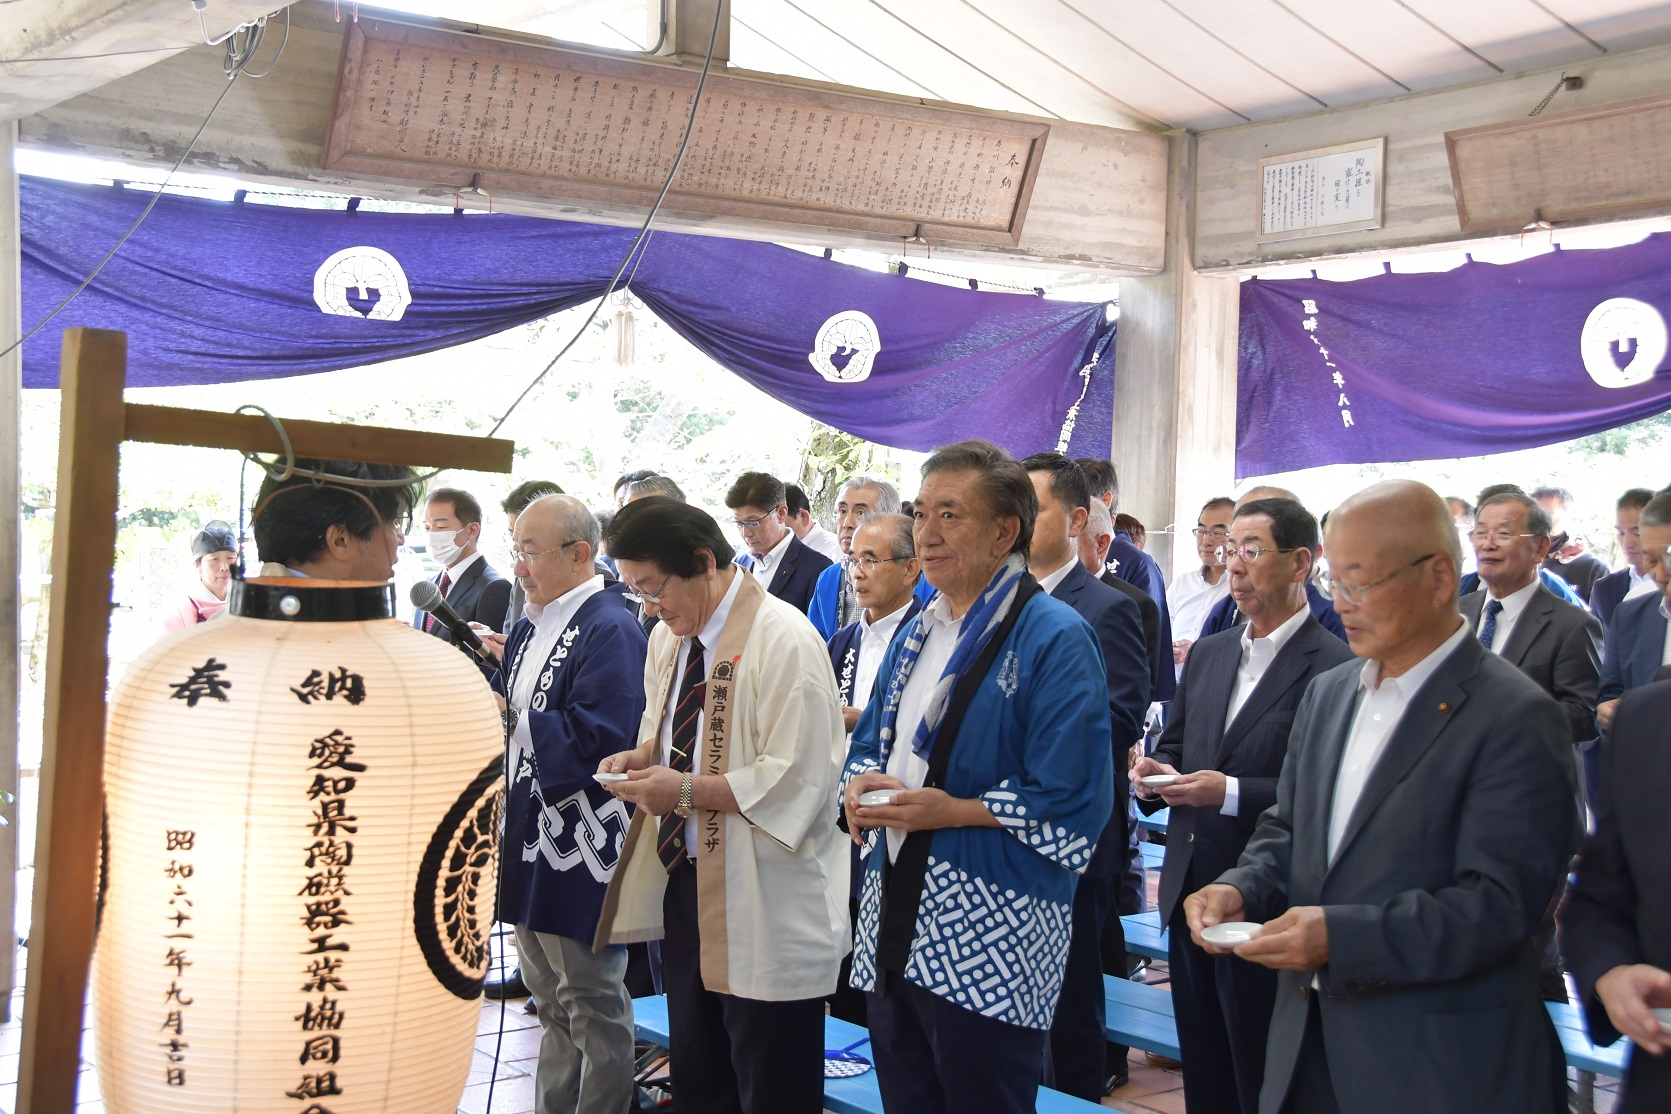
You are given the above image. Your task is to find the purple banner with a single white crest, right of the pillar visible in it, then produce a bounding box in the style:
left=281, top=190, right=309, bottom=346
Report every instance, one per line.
left=1237, top=234, right=1671, bottom=478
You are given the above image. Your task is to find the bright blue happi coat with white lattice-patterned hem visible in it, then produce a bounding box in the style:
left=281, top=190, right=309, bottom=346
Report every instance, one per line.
left=842, top=593, right=1115, bottom=1029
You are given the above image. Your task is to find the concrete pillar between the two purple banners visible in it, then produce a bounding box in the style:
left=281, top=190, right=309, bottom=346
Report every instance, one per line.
left=1110, top=132, right=1240, bottom=581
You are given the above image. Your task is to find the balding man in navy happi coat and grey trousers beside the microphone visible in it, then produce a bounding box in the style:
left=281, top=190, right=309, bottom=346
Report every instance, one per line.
left=495, top=494, right=647, bottom=1114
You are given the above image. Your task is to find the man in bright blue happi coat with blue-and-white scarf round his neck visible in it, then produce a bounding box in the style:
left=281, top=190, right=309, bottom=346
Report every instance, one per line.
left=842, top=441, right=1113, bottom=1111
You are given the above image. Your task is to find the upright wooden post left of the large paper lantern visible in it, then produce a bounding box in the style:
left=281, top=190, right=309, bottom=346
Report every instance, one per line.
left=17, top=329, right=127, bottom=1114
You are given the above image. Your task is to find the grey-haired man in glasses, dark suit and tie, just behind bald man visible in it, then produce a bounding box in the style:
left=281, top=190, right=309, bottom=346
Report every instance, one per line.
left=1462, top=491, right=1601, bottom=743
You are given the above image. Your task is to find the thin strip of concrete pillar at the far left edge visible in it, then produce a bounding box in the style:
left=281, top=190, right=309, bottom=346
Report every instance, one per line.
left=0, top=120, right=23, bottom=1020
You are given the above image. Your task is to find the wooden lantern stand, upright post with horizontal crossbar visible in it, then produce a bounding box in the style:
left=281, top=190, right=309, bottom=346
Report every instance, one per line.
left=17, top=329, right=515, bottom=1114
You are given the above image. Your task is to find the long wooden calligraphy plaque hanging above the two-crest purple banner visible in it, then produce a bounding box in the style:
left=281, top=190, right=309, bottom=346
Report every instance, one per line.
left=324, top=18, right=1049, bottom=246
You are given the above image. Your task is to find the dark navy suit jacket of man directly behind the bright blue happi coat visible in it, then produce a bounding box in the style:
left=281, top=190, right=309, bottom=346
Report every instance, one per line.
left=1049, top=561, right=1151, bottom=879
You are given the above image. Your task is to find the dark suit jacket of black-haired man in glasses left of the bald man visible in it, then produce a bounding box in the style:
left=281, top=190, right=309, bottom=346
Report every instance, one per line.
left=1138, top=615, right=1352, bottom=924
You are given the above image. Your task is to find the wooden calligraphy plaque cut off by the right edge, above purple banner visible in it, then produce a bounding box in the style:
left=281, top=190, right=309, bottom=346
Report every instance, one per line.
left=1445, top=97, right=1671, bottom=232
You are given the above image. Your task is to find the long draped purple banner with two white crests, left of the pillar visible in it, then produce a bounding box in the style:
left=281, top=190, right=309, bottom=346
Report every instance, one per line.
left=22, top=179, right=1115, bottom=456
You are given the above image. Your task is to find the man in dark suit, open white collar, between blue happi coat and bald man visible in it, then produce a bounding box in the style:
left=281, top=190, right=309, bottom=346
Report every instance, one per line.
left=1131, top=499, right=1352, bottom=1114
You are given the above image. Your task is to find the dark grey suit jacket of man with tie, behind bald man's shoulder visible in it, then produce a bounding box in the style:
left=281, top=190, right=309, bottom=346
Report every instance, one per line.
left=1460, top=583, right=1601, bottom=743
